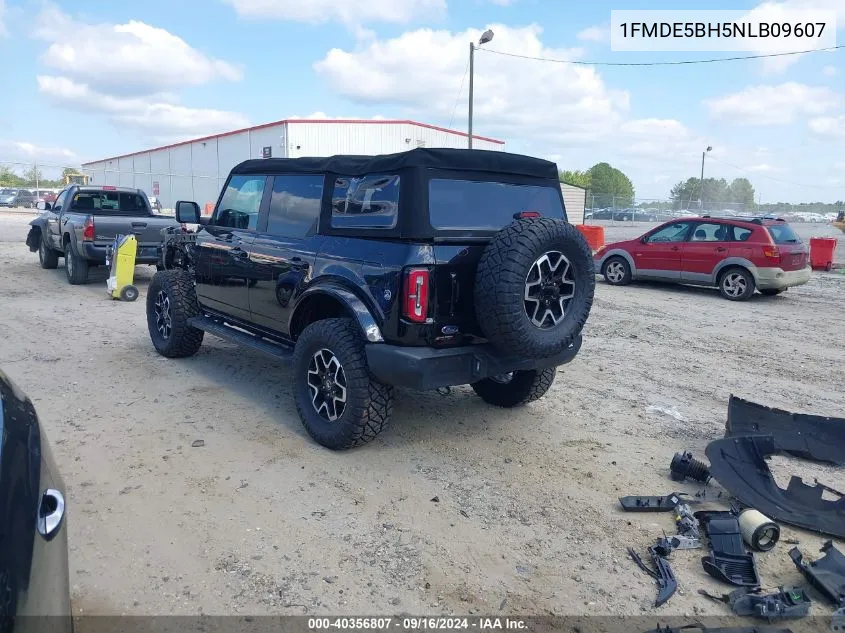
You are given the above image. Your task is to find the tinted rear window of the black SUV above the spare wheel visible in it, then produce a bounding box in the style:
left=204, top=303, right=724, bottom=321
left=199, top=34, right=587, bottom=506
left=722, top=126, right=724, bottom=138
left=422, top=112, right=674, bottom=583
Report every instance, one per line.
left=428, top=178, right=563, bottom=231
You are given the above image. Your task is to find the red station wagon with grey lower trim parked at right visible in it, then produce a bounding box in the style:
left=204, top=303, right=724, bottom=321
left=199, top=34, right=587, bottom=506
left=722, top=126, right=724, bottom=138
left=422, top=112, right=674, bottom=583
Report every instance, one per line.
left=594, top=215, right=810, bottom=301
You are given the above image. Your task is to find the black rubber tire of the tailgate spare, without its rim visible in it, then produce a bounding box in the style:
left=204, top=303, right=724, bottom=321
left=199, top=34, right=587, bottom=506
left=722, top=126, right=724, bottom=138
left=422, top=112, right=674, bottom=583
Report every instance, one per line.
left=475, top=218, right=596, bottom=357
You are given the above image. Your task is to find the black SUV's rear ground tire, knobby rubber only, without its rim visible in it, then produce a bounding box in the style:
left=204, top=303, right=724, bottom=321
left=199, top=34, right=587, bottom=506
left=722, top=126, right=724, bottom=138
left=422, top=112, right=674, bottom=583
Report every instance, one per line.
left=293, top=318, right=393, bottom=450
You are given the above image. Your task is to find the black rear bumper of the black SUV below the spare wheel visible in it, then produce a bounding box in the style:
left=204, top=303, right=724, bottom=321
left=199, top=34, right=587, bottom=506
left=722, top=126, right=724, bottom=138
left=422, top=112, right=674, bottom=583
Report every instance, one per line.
left=367, top=334, right=582, bottom=390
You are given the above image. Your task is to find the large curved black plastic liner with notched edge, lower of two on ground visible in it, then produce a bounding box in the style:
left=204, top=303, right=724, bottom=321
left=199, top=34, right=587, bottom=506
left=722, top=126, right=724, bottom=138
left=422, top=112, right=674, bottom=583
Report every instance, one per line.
left=706, top=435, right=845, bottom=538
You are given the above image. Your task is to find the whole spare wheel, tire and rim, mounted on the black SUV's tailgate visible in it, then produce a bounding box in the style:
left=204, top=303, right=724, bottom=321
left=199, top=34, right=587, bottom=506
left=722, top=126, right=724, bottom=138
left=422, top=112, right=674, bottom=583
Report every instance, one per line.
left=475, top=218, right=596, bottom=357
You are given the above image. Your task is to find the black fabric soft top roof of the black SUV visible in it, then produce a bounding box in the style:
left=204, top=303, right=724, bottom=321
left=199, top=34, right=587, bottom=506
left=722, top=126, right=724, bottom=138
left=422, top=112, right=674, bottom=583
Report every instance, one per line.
left=232, top=148, right=558, bottom=181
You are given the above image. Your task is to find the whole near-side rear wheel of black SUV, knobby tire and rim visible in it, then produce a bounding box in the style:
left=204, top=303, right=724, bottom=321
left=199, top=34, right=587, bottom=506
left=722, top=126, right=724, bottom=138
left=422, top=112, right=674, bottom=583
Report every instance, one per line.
left=293, top=319, right=393, bottom=450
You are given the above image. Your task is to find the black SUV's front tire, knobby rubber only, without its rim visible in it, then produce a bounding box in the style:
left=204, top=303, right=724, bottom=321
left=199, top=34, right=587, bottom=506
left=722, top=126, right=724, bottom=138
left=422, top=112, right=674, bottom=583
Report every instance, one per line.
left=147, top=270, right=204, bottom=358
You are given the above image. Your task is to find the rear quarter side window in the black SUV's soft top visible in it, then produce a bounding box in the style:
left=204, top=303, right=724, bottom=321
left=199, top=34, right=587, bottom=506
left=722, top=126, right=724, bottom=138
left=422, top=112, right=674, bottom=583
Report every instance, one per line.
left=332, top=174, right=399, bottom=229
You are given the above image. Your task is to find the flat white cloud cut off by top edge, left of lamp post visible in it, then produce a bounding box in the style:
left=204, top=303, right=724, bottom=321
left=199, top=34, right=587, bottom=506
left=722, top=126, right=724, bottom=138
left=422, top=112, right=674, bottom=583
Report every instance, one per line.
left=223, top=0, right=446, bottom=24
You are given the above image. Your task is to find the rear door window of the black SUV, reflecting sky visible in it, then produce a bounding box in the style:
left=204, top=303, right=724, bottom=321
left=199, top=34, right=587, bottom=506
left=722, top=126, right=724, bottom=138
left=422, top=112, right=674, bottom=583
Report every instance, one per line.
left=267, top=175, right=324, bottom=238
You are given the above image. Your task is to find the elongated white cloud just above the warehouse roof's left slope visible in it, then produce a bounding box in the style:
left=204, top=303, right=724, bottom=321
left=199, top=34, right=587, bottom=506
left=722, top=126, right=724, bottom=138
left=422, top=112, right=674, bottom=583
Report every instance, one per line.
left=37, top=75, right=249, bottom=138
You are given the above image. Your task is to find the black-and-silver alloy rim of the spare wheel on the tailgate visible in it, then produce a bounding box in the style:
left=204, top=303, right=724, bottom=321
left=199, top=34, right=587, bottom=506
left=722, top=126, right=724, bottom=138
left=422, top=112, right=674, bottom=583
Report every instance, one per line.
left=524, top=251, right=575, bottom=330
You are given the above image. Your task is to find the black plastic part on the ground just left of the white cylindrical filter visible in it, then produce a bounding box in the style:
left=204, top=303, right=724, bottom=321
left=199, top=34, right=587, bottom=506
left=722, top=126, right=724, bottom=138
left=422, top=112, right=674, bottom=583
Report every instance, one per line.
left=695, top=511, right=760, bottom=587
